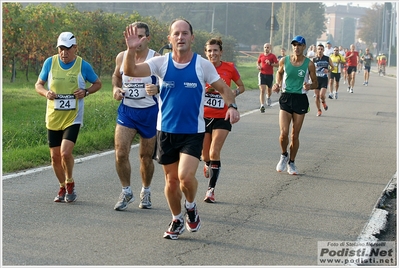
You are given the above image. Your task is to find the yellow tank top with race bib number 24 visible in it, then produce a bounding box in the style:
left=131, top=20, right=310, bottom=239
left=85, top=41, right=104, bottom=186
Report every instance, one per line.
left=46, top=55, right=85, bottom=130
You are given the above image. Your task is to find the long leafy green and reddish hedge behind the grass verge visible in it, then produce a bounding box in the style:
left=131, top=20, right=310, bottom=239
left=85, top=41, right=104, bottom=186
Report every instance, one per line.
left=2, top=3, right=236, bottom=82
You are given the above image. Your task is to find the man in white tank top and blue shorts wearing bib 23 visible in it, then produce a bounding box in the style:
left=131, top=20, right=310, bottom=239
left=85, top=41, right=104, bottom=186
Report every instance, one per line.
left=112, top=22, right=159, bottom=211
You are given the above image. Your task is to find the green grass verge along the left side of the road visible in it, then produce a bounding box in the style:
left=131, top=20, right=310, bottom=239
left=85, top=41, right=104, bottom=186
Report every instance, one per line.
left=2, top=58, right=258, bottom=173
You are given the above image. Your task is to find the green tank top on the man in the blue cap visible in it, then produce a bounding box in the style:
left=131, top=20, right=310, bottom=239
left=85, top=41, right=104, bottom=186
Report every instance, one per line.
left=282, top=56, right=309, bottom=94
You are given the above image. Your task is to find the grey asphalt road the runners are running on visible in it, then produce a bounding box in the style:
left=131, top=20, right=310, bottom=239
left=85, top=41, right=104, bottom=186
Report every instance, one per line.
left=2, top=70, right=397, bottom=266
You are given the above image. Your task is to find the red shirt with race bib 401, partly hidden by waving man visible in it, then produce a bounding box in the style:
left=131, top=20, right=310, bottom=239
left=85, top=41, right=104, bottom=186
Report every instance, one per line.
left=204, top=61, right=241, bottom=118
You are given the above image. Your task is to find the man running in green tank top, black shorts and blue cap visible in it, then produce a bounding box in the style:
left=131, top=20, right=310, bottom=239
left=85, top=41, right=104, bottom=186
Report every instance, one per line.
left=273, top=35, right=317, bottom=175
